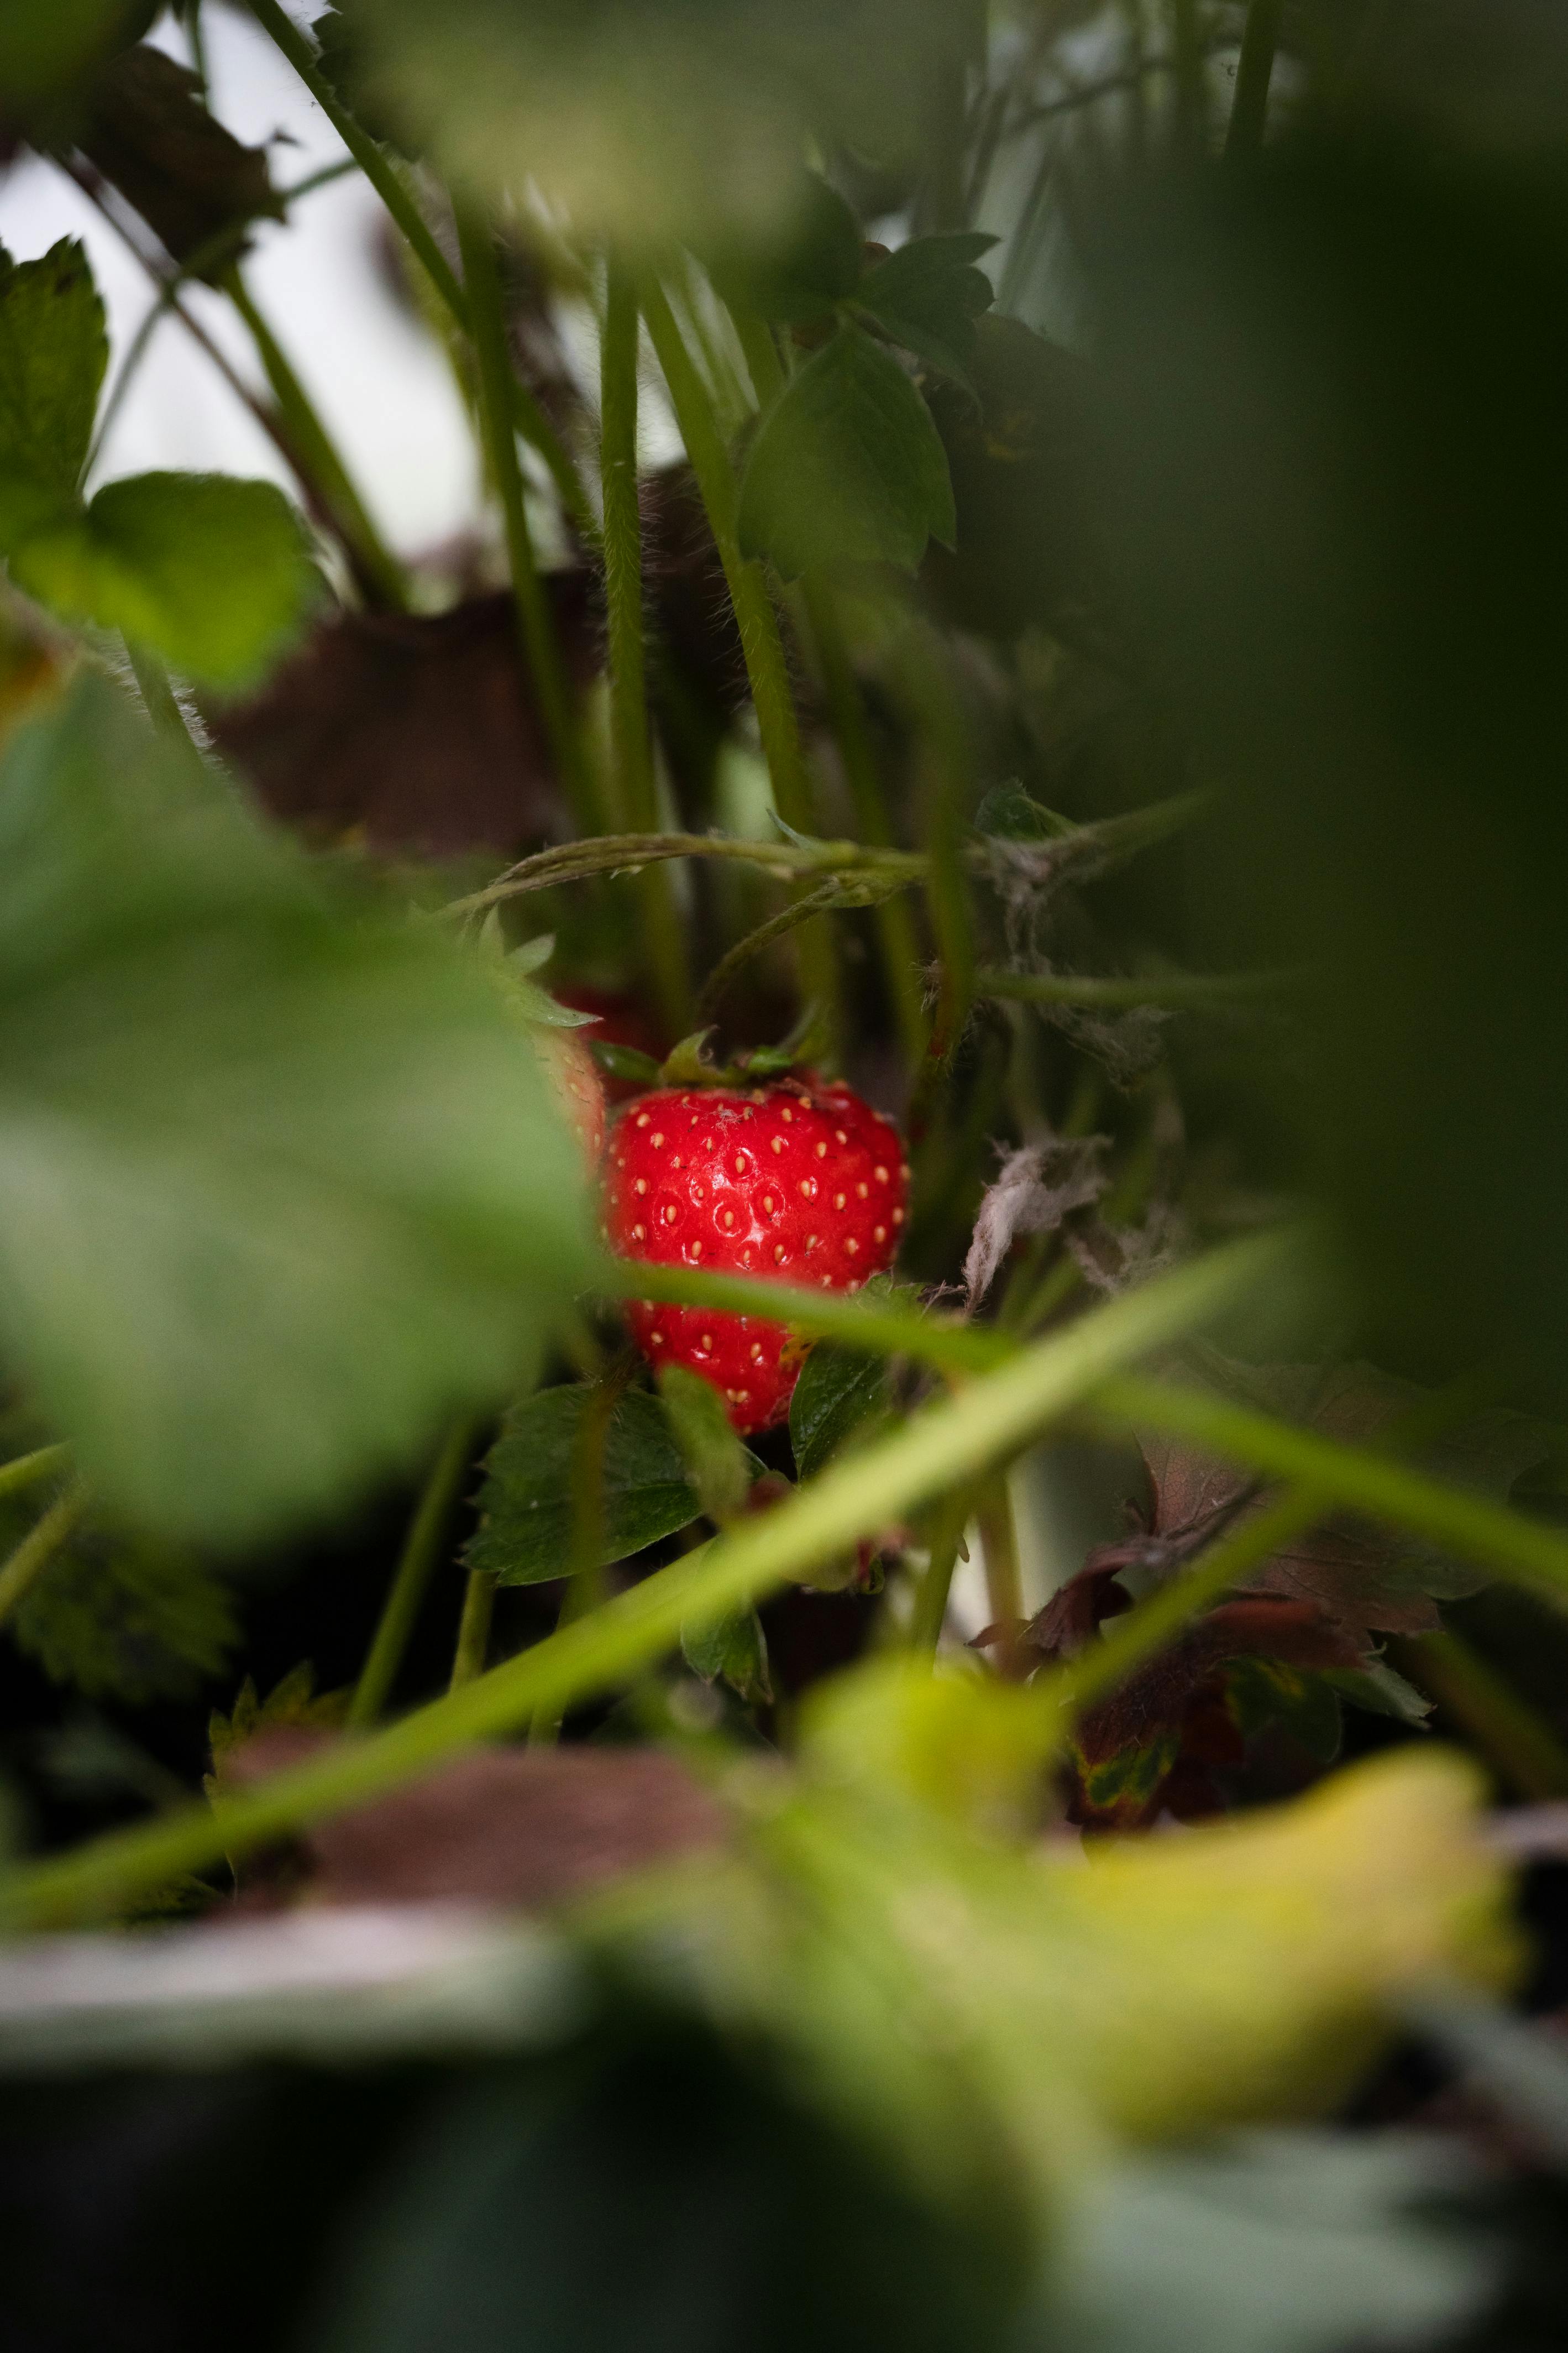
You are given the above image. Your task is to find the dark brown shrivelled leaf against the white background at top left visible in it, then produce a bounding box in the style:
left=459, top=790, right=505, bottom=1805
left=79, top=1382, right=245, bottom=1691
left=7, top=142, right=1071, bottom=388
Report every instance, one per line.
left=75, top=43, right=285, bottom=285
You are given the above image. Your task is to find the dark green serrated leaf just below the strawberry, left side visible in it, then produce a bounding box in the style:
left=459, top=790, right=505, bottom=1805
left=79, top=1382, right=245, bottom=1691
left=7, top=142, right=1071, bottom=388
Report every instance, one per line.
left=465, top=1384, right=762, bottom=1586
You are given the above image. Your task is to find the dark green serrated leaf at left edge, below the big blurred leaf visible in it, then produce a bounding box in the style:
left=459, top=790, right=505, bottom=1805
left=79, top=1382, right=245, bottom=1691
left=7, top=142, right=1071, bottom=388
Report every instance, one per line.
left=12, top=1529, right=240, bottom=1706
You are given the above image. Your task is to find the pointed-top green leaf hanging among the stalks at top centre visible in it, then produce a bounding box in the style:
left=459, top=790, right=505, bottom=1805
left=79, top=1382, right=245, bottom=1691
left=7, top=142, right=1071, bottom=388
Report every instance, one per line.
left=741, top=327, right=957, bottom=579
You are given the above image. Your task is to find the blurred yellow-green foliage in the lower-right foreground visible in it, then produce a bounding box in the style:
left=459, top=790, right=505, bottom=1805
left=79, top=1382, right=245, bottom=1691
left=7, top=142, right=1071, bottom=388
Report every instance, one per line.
left=583, top=1659, right=1516, bottom=2231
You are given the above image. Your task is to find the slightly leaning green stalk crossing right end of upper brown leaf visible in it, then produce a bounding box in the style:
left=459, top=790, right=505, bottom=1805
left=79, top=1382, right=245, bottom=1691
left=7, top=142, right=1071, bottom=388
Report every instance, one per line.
left=456, top=205, right=597, bottom=833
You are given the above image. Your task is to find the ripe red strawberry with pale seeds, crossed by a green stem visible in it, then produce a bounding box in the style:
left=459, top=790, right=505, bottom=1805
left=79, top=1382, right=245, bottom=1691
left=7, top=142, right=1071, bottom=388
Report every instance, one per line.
left=604, top=1080, right=910, bottom=1431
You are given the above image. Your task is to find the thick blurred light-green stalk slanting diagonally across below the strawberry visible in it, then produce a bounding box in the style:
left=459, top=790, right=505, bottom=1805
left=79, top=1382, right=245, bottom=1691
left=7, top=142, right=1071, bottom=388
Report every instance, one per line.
left=0, top=1240, right=1281, bottom=1927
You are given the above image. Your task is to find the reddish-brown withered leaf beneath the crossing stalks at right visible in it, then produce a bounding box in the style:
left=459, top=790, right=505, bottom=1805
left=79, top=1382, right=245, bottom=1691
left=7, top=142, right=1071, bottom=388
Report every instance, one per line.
left=1140, top=1351, right=1561, bottom=1635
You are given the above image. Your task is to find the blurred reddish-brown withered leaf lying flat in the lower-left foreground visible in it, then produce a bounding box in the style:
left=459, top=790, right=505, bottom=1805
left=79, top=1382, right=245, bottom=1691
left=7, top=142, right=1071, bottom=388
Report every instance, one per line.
left=223, top=1727, right=726, bottom=1911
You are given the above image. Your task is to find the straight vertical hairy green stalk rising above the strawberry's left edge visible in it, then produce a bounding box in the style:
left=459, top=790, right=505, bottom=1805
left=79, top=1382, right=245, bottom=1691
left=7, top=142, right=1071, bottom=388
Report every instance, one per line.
left=600, top=254, right=694, bottom=1038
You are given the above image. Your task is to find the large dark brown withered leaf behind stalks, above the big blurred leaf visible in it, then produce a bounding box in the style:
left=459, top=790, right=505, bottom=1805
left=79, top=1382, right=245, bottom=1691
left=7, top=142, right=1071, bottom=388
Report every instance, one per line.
left=207, top=585, right=597, bottom=859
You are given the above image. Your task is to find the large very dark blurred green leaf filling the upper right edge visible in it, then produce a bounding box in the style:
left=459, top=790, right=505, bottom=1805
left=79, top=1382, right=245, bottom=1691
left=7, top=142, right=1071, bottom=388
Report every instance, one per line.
left=1095, top=119, right=1568, bottom=1390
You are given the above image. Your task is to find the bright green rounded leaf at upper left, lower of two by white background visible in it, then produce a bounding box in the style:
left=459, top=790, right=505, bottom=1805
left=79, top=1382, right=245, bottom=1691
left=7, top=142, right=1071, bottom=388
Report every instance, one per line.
left=12, top=473, right=319, bottom=692
